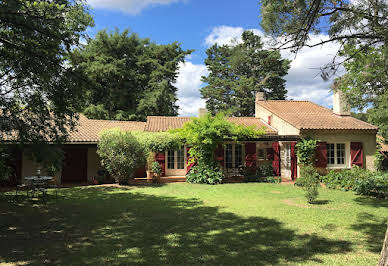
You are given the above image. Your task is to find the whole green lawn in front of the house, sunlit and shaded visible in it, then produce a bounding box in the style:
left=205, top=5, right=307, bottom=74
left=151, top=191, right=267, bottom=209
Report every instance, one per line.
left=0, top=183, right=388, bottom=265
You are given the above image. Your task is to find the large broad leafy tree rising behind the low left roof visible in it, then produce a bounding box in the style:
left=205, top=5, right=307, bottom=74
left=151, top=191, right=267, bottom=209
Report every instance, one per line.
left=72, top=30, right=192, bottom=120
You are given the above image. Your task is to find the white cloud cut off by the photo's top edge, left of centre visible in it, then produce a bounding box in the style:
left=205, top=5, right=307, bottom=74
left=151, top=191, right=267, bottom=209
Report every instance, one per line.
left=87, top=0, right=182, bottom=15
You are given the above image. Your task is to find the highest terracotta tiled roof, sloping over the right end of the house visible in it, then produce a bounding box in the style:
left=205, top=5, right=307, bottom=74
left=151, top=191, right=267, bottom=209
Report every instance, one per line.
left=257, top=100, right=377, bottom=130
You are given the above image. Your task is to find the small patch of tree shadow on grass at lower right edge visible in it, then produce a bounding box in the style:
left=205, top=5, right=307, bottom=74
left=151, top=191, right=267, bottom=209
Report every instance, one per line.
left=351, top=212, right=387, bottom=253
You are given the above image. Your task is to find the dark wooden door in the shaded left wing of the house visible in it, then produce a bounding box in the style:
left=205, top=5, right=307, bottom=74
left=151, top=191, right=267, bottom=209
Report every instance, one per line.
left=62, top=148, right=88, bottom=183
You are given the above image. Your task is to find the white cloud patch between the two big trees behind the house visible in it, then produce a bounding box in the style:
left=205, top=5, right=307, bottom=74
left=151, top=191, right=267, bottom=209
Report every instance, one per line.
left=175, top=61, right=208, bottom=116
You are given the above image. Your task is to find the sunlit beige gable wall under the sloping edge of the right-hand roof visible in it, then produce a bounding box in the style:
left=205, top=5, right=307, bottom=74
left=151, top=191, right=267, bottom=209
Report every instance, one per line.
left=255, top=103, right=299, bottom=135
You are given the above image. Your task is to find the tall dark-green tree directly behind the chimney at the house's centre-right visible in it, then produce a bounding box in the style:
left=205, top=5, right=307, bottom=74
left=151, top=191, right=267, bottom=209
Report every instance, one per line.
left=200, top=31, right=290, bottom=116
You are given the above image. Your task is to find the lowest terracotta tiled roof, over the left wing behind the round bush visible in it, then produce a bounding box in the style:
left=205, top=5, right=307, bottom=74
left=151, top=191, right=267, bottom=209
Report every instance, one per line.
left=69, top=114, right=146, bottom=143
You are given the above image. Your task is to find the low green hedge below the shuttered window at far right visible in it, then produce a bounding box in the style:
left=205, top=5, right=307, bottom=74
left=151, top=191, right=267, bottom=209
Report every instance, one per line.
left=322, top=167, right=388, bottom=197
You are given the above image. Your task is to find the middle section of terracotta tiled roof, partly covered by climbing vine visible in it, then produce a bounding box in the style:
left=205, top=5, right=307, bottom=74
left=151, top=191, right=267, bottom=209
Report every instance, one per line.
left=145, top=116, right=276, bottom=134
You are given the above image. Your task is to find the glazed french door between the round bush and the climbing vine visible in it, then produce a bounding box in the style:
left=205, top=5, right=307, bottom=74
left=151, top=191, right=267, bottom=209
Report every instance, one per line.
left=166, top=147, right=187, bottom=176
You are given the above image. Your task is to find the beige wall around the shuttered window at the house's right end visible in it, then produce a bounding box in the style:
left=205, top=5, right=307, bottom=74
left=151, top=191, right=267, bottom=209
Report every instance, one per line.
left=301, top=130, right=376, bottom=170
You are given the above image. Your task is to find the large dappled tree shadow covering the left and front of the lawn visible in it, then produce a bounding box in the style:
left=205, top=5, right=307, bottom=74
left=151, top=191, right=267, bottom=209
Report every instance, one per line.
left=0, top=188, right=352, bottom=265
